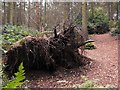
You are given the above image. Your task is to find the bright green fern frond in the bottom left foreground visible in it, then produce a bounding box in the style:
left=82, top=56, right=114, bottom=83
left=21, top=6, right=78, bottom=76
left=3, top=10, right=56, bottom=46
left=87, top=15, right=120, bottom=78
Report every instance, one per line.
left=3, top=63, right=25, bottom=88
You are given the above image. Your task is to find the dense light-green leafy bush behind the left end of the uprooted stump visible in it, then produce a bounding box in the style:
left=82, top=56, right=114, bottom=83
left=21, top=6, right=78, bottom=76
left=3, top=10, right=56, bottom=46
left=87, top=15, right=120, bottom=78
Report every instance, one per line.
left=0, top=25, right=32, bottom=50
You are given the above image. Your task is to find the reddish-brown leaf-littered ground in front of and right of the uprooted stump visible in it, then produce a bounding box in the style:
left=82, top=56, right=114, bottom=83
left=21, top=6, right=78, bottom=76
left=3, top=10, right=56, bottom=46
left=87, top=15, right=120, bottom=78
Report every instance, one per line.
left=27, top=34, right=118, bottom=88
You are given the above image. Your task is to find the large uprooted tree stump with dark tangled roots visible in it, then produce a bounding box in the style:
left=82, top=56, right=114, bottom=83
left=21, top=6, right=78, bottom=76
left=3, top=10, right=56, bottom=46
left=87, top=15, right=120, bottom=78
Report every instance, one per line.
left=4, top=25, right=92, bottom=75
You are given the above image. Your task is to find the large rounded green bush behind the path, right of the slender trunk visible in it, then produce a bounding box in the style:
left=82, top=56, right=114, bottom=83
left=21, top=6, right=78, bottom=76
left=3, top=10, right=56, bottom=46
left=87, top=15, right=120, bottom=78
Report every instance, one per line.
left=87, top=7, right=109, bottom=34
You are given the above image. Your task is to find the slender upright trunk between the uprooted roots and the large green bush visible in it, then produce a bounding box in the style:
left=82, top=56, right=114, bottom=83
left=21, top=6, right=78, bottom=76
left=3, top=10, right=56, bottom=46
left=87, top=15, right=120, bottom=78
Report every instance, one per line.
left=82, top=2, right=88, bottom=40
